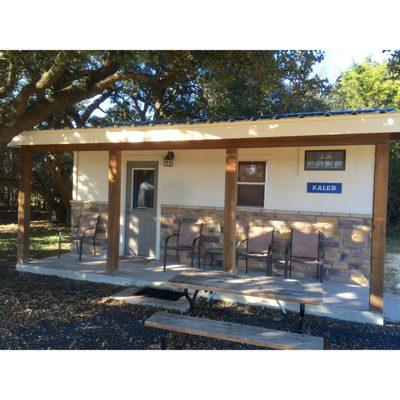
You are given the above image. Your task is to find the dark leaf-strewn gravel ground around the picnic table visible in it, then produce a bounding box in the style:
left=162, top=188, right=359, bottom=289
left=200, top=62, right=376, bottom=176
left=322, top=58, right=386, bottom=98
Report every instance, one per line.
left=0, top=266, right=400, bottom=349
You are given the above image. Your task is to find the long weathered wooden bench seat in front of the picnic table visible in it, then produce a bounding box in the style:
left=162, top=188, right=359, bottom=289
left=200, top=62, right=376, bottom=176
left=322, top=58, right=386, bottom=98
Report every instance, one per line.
left=145, top=312, right=324, bottom=350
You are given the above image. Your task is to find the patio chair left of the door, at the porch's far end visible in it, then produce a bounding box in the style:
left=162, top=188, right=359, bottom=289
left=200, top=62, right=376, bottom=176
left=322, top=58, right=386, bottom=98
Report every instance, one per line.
left=58, top=213, right=100, bottom=261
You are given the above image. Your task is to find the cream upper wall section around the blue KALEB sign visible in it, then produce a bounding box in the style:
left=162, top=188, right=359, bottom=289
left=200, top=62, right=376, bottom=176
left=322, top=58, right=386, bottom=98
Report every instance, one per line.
left=260, top=146, right=375, bottom=214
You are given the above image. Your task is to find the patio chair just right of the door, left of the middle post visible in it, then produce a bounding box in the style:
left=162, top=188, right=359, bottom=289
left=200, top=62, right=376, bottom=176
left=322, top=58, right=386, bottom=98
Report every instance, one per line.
left=164, top=220, right=203, bottom=271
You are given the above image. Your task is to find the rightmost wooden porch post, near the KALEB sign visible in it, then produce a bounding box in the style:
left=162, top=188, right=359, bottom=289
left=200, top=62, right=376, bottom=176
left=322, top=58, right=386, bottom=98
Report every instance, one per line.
left=369, top=141, right=390, bottom=312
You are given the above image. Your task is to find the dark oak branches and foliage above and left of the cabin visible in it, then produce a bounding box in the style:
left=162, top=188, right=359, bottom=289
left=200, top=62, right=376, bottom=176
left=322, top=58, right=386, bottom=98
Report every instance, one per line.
left=0, top=50, right=328, bottom=221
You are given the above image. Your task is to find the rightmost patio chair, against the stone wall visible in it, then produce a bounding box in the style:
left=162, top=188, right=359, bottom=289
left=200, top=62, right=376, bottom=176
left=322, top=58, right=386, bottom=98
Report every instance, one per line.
left=285, top=229, right=324, bottom=282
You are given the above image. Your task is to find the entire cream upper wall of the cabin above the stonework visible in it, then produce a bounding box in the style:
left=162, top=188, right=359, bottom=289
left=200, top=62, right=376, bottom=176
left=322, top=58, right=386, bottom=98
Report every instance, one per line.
left=74, top=146, right=374, bottom=214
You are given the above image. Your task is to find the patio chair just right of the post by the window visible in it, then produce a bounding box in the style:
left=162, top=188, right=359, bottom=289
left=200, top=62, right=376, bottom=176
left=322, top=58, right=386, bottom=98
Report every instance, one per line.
left=236, top=226, right=274, bottom=276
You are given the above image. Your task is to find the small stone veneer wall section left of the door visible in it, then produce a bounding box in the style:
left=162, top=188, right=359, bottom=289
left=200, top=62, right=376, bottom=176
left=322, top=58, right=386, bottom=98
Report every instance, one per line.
left=71, top=201, right=108, bottom=256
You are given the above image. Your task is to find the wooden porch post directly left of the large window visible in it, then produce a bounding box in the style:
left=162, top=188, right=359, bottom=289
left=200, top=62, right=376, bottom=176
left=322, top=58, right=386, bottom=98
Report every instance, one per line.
left=224, top=148, right=238, bottom=272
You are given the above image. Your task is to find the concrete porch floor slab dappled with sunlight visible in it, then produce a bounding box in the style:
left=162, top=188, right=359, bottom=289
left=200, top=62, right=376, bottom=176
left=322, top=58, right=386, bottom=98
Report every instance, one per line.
left=17, top=253, right=400, bottom=325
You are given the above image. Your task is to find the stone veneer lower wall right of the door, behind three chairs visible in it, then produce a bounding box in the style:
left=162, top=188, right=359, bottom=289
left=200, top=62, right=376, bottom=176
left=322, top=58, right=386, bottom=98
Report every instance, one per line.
left=160, top=206, right=372, bottom=284
